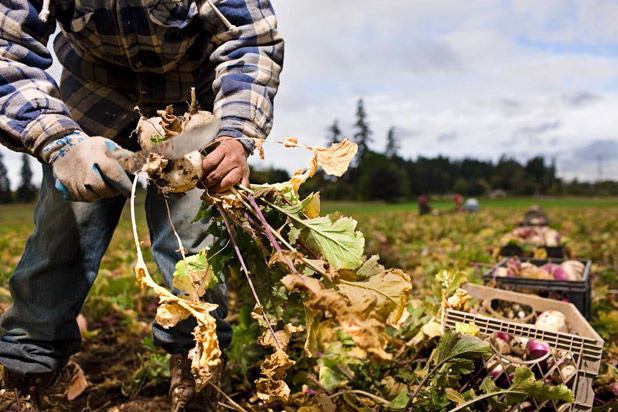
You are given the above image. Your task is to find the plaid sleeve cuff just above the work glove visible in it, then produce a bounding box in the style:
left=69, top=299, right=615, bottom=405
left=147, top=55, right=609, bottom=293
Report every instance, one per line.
left=22, top=114, right=89, bottom=163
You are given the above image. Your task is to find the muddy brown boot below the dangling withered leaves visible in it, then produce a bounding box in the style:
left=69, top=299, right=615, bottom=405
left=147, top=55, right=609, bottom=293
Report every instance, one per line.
left=170, top=353, right=223, bottom=412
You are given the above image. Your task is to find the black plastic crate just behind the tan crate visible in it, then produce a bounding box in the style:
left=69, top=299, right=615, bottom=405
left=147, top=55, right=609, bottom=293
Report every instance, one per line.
left=483, top=258, right=592, bottom=319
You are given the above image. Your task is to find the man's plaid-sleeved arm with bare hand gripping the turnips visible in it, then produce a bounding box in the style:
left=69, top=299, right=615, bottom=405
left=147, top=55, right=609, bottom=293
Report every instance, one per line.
left=203, top=0, right=283, bottom=191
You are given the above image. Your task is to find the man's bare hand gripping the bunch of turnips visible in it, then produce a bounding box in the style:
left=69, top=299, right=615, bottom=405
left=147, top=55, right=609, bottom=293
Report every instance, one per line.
left=202, top=137, right=249, bottom=192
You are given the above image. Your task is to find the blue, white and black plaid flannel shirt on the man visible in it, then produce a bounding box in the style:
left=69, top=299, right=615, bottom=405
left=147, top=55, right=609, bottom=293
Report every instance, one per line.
left=0, top=0, right=283, bottom=161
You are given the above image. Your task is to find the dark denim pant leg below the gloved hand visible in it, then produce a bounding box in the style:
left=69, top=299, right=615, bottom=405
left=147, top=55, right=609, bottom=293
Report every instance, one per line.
left=0, top=165, right=126, bottom=375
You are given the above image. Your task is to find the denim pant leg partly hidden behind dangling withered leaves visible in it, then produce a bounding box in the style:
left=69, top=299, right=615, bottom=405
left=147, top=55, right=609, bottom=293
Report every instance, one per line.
left=146, top=185, right=232, bottom=354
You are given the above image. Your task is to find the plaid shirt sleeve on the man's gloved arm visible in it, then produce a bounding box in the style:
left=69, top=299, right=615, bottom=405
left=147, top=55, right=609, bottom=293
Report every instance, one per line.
left=0, top=0, right=79, bottom=156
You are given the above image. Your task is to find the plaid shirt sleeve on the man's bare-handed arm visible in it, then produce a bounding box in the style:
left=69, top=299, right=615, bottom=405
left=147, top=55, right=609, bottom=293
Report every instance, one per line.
left=210, top=0, right=283, bottom=151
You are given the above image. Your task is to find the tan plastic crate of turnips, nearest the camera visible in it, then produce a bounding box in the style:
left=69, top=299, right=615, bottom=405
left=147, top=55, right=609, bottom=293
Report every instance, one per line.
left=444, top=284, right=604, bottom=412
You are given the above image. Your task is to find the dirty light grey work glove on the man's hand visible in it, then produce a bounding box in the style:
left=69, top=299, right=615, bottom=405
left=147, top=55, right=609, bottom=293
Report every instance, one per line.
left=41, top=131, right=133, bottom=202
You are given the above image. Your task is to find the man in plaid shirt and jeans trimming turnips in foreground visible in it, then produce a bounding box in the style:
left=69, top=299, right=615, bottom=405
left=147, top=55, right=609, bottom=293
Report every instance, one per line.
left=0, top=0, right=283, bottom=411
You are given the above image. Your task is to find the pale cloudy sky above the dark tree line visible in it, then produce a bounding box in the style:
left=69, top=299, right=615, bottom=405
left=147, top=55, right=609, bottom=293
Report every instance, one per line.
left=0, top=0, right=618, bottom=185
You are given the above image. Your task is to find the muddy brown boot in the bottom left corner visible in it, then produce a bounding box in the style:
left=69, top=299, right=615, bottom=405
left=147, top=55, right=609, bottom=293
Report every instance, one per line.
left=0, top=369, right=58, bottom=412
